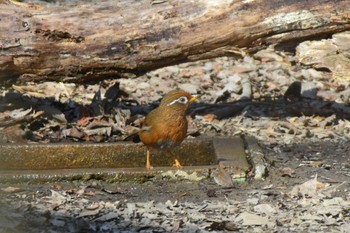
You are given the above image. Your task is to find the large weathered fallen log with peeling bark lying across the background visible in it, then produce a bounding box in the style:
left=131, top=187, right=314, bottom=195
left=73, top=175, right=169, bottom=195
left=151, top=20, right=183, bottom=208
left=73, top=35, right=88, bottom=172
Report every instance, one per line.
left=0, top=0, right=350, bottom=82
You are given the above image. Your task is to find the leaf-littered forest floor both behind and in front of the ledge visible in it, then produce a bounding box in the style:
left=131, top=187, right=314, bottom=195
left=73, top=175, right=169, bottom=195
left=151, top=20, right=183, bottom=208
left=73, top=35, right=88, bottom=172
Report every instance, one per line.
left=0, top=33, right=350, bottom=232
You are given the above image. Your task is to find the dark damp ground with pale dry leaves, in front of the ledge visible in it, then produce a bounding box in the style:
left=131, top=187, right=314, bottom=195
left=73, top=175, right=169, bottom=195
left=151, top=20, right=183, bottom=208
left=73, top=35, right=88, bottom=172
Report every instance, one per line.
left=0, top=141, right=350, bottom=232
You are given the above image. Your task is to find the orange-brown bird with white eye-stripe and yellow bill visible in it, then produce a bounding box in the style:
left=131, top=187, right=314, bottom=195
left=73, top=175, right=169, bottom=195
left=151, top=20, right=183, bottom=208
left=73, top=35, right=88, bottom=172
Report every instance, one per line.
left=139, top=89, right=198, bottom=169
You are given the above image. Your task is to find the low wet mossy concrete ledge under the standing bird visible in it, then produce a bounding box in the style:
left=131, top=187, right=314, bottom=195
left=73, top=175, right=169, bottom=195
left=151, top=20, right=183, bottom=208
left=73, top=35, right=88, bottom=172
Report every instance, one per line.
left=0, top=137, right=249, bottom=181
